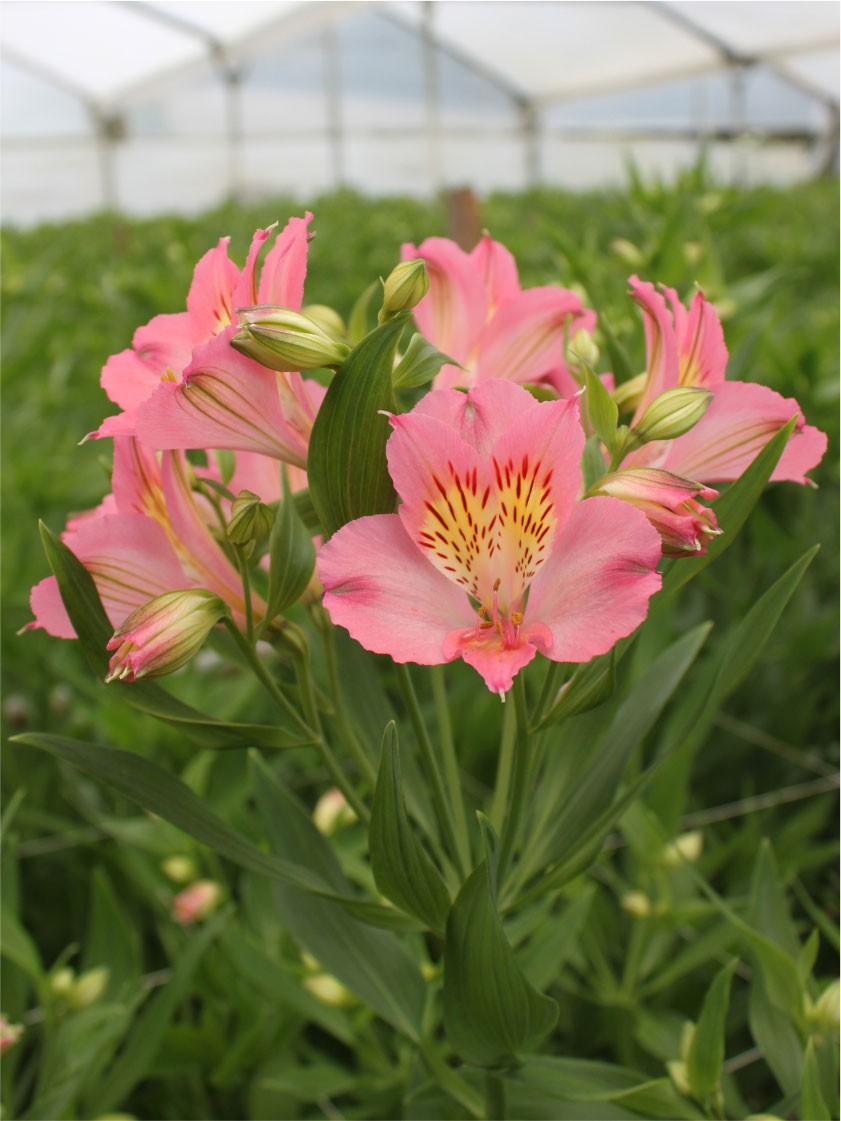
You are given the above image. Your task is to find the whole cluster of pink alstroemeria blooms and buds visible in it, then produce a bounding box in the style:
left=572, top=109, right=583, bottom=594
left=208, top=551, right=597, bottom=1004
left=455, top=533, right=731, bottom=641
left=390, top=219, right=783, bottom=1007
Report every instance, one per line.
left=30, top=214, right=826, bottom=695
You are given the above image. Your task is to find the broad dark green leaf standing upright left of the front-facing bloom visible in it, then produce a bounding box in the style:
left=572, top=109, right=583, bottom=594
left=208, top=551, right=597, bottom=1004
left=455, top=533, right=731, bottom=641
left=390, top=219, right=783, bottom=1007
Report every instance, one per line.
left=307, top=312, right=409, bottom=534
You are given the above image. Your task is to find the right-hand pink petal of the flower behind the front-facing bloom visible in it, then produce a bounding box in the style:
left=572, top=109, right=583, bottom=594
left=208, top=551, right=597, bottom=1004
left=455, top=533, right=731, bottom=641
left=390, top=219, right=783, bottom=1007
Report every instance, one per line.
left=477, top=287, right=583, bottom=385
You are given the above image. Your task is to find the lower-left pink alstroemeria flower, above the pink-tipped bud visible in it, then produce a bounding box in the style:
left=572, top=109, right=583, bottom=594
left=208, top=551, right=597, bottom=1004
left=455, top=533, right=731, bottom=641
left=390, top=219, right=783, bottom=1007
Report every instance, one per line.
left=29, top=437, right=266, bottom=638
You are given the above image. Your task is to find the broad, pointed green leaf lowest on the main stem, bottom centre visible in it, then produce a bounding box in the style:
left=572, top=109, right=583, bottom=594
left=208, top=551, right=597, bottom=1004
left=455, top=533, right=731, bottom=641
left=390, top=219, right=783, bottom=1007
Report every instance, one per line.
left=444, top=830, right=558, bottom=1066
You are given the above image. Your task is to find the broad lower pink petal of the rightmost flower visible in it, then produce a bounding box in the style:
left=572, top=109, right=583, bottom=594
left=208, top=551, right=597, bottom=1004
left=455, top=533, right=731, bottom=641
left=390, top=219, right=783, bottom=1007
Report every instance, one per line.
left=658, top=381, right=826, bottom=483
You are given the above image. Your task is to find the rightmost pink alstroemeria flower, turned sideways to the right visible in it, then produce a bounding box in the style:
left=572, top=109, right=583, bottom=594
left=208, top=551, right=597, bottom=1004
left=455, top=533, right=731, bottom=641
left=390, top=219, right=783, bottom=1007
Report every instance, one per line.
left=623, top=277, right=826, bottom=483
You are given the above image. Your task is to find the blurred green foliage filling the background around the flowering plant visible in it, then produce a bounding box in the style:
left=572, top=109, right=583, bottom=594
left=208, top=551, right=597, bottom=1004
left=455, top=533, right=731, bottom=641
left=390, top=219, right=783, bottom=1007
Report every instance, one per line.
left=0, top=170, right=839, bottom=1118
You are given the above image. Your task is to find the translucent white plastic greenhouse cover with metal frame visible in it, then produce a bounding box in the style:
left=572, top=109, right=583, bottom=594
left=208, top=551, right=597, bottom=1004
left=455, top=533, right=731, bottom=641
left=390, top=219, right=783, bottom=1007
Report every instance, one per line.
left=0, top=0, right=840, bottom=221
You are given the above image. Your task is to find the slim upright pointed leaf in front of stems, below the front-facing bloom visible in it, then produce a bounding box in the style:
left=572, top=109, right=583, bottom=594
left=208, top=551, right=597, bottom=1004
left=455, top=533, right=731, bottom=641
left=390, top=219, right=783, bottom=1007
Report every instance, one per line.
left=368, top=723, right=450, bottom=934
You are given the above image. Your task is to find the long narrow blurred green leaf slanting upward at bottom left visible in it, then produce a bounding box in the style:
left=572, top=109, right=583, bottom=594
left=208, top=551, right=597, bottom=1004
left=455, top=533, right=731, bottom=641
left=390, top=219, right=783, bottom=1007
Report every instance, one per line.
left=85, top=908, right=232, bottom=1117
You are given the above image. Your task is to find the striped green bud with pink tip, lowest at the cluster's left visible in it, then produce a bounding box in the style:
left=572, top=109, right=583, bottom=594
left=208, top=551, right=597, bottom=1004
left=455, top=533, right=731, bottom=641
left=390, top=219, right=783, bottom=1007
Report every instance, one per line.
left=105, top=587, right=228, bottom=682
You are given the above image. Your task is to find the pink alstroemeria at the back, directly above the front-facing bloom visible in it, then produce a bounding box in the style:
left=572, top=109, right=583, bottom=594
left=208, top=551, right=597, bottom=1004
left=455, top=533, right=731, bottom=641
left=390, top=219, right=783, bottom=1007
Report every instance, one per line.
left=401, top=234, right=595, bottom=396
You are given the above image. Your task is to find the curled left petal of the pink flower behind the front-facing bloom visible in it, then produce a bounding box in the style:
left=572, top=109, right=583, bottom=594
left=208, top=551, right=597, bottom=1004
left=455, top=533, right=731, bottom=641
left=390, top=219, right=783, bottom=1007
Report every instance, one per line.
left=400, top=238, right=488, bottom=369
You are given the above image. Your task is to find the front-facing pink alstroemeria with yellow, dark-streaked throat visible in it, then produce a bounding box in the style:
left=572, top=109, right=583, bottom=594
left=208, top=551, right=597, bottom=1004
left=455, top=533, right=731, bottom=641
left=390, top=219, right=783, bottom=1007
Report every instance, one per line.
left=318, top=380, right=660, bottom=696
